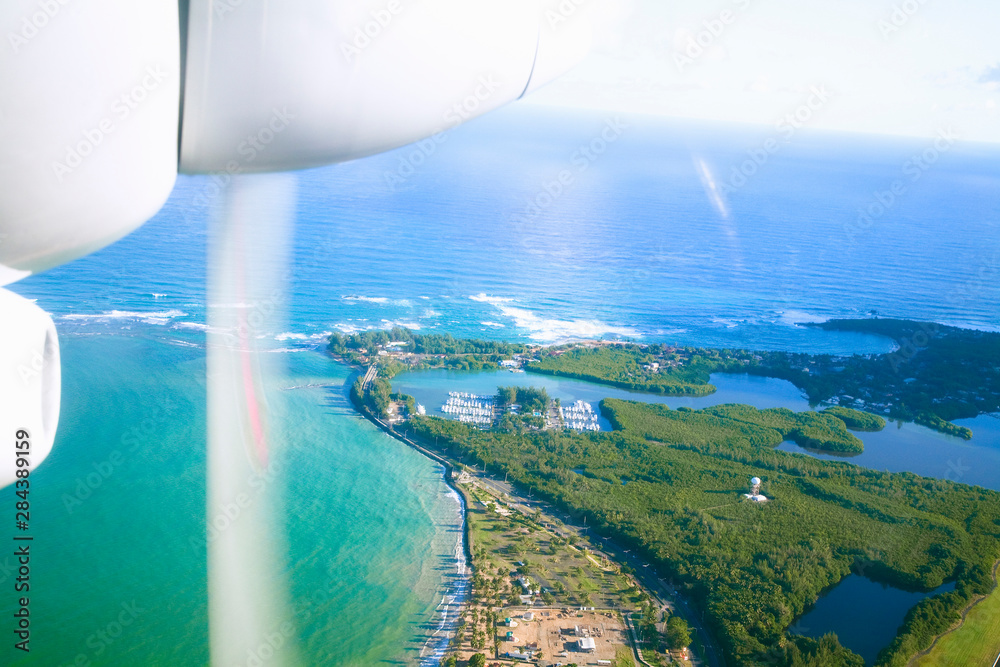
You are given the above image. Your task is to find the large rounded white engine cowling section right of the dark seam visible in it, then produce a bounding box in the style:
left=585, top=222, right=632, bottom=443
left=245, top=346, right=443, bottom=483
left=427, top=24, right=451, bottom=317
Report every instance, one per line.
left=181, top=0, right=589, bottom=173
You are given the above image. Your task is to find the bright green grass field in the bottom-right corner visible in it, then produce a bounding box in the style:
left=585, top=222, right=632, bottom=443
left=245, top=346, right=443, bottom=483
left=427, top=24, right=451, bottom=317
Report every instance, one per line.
left=910, top=587, right=1000, bottom=667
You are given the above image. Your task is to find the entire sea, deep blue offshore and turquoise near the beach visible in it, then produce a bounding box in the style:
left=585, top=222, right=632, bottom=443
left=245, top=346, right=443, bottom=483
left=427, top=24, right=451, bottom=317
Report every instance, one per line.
left=7, top=106, right=1000, bottom=665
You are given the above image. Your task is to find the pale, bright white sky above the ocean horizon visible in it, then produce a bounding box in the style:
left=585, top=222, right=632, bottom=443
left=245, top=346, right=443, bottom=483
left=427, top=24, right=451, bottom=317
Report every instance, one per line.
left=525, top=0, right=1000, bottom=143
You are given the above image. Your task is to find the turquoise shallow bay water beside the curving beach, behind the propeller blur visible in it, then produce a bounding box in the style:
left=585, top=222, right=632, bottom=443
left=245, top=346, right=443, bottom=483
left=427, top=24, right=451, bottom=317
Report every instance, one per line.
left=0, top=336, right=461, bottom=666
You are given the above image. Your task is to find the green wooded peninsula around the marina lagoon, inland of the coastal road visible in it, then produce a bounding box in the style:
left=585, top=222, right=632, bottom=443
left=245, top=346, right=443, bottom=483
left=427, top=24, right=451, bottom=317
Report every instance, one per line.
left=330, top=320, right=1000, bottom=667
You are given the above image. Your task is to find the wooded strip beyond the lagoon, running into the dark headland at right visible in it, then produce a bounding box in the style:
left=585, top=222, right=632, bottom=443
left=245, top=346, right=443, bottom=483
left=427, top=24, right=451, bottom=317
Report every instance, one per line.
left=526, top=319, right=1000, bottom=440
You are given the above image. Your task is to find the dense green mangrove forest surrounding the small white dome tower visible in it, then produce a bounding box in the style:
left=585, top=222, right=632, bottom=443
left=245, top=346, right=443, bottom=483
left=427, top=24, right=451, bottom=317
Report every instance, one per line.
left=402, top=400, right=1000, bottom=667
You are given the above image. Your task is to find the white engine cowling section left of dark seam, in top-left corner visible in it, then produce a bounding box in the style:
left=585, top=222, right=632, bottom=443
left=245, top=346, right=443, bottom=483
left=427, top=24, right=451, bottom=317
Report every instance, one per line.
left=0, top=0, right=181, bottom=285
